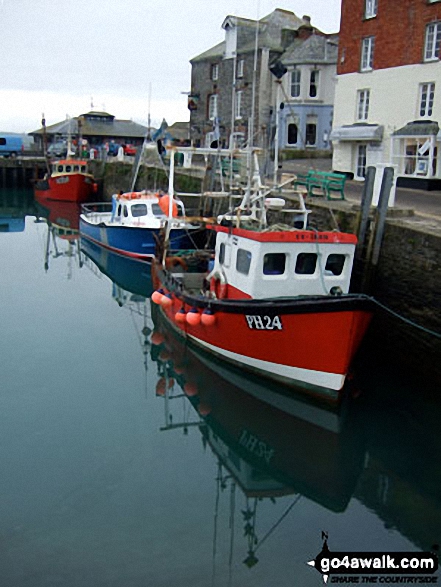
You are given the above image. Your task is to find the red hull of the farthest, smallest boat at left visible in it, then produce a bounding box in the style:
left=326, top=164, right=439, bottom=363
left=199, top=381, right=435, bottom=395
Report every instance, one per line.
left=35, top=173, right=96, bottom=202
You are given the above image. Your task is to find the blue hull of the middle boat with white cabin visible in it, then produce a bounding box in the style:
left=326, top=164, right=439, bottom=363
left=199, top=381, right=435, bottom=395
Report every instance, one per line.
left=80, top=215, right=199, bottom=261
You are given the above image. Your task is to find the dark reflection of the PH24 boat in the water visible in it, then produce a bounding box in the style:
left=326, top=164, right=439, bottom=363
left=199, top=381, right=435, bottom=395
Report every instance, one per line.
left=151, top=304, right=365, bottom=566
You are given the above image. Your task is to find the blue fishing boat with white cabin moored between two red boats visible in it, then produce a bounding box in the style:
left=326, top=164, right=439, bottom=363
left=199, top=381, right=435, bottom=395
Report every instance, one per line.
left=80, top=191, right=200, bottom=261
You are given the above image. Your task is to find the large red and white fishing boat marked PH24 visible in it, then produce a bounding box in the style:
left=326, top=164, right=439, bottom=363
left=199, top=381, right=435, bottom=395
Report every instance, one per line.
left=152, top=148, right=374, bottom=400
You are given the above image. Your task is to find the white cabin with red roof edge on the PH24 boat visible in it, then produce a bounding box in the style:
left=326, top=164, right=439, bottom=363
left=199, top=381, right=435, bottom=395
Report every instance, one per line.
left=209, top=226, right=357, bottom=299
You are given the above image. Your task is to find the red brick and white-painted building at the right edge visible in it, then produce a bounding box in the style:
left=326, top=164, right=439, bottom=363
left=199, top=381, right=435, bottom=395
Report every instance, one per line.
left=331, top=0, right=441, bottom=189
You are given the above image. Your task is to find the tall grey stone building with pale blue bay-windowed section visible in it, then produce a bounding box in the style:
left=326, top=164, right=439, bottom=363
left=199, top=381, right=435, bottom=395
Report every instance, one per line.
left=188, top=9, right=336, bottom=148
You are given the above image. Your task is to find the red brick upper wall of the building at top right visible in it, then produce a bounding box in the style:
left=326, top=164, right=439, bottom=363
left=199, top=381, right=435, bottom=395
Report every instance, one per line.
left=337, top=0, right=441, bottom=74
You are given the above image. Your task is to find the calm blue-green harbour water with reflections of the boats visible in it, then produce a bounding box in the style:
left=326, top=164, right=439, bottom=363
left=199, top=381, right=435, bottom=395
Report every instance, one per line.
left=0, top=189, right=441, bottom=587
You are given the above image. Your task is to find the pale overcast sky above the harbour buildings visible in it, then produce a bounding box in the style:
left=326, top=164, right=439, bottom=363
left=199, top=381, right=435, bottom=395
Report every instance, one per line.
left=0, top=0, right=341, bottom=133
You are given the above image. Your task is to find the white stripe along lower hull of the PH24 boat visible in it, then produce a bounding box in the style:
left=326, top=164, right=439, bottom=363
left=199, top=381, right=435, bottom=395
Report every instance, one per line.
left=187, top=333, right=346, bottom=391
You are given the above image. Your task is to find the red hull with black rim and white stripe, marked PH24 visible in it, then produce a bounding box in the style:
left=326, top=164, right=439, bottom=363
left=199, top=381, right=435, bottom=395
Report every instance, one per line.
left=150, top=266, right=373, bottom=400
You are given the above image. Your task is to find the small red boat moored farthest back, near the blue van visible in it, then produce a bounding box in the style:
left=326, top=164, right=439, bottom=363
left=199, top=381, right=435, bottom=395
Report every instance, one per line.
left=35, top=159, right=98, bottom=202
